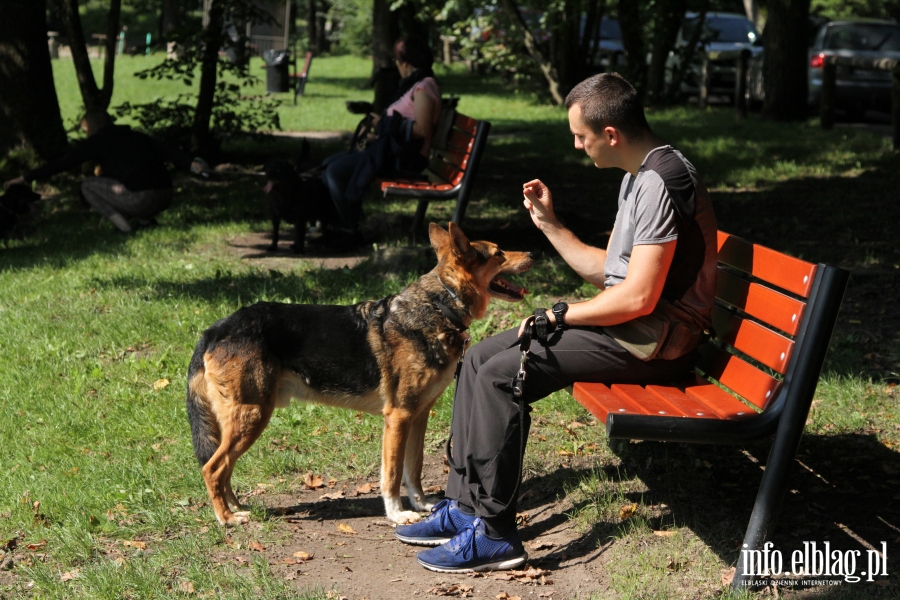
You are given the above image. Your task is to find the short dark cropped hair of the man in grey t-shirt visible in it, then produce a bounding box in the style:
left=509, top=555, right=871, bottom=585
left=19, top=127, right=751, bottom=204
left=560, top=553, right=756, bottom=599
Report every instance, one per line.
left=566, top=73, right=650, bottom=136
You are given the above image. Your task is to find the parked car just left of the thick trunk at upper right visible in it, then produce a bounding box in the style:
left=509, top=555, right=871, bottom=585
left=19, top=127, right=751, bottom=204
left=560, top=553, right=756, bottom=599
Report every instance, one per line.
left=666, top=12, right=762, bottom=98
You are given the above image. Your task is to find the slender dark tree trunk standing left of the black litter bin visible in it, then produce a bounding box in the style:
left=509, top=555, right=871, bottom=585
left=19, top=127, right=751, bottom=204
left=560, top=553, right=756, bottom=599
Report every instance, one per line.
left=191, top=0, right=226, bottom=156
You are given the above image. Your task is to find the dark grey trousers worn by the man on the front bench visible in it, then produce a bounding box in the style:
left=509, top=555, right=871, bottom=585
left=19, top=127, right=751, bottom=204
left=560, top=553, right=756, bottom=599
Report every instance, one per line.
left=446, top=327, right=696, bottom=535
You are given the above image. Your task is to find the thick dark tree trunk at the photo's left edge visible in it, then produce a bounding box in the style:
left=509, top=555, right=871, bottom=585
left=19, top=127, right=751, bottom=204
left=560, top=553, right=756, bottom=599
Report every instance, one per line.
left=0, top=0, right=68, bottom=159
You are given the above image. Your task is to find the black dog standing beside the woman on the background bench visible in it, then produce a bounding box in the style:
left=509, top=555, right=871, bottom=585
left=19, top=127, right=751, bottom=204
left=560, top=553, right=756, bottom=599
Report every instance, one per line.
left=265, top=154, right=337, bottom=254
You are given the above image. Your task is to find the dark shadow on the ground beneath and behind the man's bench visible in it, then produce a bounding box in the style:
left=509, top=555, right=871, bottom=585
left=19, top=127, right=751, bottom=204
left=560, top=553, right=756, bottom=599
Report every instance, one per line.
left=519, top=434, right=900, bottom=598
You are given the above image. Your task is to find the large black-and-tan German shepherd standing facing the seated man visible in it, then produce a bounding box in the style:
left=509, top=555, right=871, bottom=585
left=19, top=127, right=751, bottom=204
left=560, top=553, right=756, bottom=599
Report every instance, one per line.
left=187, top=223, right=532, bottom=525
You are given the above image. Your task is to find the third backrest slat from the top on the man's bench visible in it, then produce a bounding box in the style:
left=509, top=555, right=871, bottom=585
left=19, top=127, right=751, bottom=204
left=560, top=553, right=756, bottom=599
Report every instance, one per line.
left=712, top=306, right=794, bottom=375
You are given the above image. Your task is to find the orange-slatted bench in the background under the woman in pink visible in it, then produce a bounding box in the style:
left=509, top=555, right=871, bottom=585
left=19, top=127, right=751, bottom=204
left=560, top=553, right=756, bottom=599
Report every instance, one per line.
left=379, top=112, right=491, bottom=232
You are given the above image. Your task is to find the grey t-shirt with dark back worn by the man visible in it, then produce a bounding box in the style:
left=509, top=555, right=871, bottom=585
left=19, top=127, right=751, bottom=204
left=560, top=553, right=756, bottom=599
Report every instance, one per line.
left=604, top=146, right=717, bottom=329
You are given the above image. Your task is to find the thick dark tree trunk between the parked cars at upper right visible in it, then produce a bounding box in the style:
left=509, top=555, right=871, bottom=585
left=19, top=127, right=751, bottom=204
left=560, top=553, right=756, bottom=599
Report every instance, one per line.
left=763, top=0, right=810, bottom=121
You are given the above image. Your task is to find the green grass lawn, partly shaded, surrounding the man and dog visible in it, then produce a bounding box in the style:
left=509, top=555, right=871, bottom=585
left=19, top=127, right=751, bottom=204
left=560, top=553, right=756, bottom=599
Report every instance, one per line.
left=0, top=57, right=900, bottom=600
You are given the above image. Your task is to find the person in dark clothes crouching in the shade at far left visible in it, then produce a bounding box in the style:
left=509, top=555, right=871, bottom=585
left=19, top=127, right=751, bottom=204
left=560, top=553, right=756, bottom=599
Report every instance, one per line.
left=4, top=110, right=207, bottom=232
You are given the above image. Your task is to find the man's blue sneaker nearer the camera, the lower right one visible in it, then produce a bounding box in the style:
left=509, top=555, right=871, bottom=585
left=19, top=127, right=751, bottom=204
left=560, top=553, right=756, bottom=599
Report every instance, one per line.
left=418, top=518, right=528, bottom=573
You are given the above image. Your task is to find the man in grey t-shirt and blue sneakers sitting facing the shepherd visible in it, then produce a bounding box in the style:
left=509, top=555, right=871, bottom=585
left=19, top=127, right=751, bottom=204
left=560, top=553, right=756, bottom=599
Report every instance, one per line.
left=395, top=73, right=716, bottom=572
